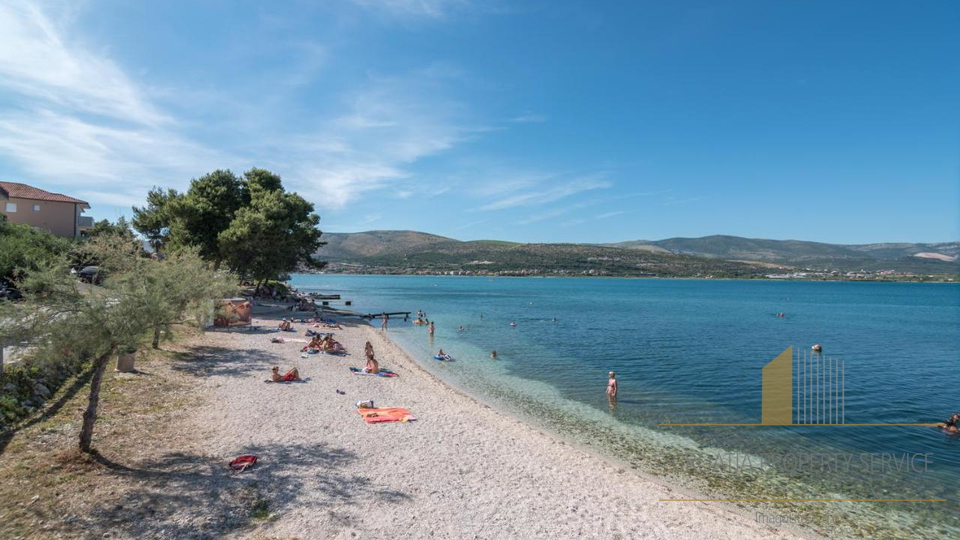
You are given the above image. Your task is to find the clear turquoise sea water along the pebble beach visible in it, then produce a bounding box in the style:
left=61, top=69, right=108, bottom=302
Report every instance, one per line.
left=293, top=275, right=960, bottom=538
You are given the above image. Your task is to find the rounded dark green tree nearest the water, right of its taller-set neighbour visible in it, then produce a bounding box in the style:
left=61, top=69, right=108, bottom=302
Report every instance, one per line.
left=219, top=178, right=324, bottom=283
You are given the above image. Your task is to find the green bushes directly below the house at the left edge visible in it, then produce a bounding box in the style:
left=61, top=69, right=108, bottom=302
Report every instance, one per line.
left=0, top=216, right=73, bottom=281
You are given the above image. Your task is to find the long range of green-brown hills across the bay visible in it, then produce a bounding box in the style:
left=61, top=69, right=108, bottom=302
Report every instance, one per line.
left=317, top=231, right=960, bottom=277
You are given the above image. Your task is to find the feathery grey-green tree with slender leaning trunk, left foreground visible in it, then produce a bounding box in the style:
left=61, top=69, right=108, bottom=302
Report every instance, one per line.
left=0, top=234, right=236, bottom=453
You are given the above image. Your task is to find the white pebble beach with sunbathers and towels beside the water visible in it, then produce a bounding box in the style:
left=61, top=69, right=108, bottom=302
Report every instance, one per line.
left=189, top=324, right=816, bottom=540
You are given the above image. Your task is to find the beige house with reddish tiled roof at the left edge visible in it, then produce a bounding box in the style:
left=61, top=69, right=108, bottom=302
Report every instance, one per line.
left=0, top=182, right=93, bottom=238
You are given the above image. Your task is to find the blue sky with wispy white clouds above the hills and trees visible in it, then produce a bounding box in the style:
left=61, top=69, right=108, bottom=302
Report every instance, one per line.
left=0, top=0, right=960, bottom=243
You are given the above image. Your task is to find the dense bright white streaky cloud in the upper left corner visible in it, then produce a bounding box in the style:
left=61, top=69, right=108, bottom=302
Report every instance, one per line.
left=0, top=2, right=224, bottom=205
